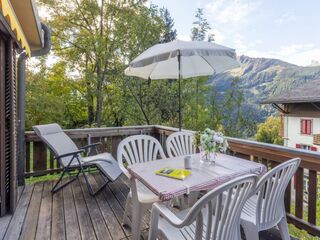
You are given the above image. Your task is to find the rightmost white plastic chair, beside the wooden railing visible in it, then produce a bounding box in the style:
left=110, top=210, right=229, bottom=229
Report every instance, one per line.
left=241, top=158, right=301, bottom=240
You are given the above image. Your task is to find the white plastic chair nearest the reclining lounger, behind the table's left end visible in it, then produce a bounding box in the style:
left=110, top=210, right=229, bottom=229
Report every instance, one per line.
left=117, top=135, right=166, bottom=239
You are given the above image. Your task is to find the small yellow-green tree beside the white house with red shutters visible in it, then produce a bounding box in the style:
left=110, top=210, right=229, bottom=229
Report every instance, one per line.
left=256, top=116, right=283, bottom=145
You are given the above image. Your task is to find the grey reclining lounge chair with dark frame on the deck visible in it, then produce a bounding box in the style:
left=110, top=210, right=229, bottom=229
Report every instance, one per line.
left=33, top=123, right=122, bottom=195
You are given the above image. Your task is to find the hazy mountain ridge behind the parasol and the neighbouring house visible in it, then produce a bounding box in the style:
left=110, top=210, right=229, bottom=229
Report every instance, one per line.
left=208, top=55, right=320, bottom=122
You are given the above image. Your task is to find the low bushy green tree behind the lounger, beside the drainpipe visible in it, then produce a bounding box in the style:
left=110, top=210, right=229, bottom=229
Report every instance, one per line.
left=26, top=58, right=87, bottom=130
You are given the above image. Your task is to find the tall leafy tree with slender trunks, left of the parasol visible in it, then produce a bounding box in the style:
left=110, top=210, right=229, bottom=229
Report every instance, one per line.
left=41, top=0, right=164, bottom=126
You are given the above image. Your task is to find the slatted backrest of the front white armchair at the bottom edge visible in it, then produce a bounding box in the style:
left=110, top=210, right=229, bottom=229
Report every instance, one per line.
left=181, top=174, right=257, bottom=240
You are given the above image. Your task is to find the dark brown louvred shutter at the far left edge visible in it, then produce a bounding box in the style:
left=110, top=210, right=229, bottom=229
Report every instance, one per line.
left=0, top=38, right=17, bottom=216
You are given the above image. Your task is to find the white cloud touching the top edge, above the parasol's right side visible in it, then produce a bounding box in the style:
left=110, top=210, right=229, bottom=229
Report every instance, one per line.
left=205, top=0, right=260, bottom=23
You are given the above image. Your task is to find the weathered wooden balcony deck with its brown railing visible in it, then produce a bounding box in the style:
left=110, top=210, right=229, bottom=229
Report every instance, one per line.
left=0, top=126, right=320, bottom=239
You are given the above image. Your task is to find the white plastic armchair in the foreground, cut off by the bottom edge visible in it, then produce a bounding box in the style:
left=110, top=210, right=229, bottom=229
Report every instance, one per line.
left=149, top=174, right=257, bottom=240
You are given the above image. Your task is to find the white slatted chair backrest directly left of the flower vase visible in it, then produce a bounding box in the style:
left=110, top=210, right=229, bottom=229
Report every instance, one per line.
left=166, top=132, right=196, bottom=157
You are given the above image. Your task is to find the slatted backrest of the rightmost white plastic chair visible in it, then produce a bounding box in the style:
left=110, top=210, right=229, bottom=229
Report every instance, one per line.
left=256, top=158, right=301, bottom=228
